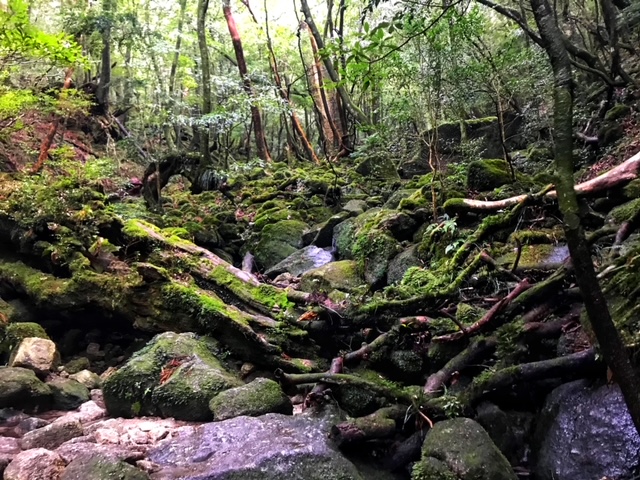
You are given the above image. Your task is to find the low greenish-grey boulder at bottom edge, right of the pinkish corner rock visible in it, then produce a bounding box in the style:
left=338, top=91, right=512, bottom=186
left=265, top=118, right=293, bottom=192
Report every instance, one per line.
left=60, top=455, right=150, bottom=480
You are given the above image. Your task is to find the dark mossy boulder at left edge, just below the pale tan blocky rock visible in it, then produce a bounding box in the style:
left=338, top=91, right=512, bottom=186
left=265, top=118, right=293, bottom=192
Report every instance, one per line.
left=0, top=367, right=53, bottom=412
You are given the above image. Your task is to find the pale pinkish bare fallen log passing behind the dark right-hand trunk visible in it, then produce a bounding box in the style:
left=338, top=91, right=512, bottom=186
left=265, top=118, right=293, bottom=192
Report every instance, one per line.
left=443, top=152, right=640, bottom=215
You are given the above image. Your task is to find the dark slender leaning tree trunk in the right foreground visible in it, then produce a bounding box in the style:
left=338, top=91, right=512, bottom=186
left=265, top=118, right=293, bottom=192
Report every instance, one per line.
left=530, top=0, right=640, bottom=431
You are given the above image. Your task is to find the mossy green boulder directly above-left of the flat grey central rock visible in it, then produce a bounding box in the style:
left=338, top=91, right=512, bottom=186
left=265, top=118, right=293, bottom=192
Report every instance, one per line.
left=253, top=220, right=307, bottom=269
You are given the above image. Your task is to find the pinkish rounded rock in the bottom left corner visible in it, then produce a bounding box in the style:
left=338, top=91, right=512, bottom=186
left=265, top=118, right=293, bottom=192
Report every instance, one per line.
left=2, top=448, right=65, bottom=480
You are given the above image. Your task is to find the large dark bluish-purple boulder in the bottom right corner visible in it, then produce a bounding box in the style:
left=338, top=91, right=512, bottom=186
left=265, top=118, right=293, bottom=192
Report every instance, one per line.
left=535, top=380, right=640, bottom=480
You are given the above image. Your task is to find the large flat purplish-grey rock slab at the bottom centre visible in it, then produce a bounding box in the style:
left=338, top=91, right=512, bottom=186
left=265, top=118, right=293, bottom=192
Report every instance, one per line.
left=148, top=413, right=362, bottom=480
